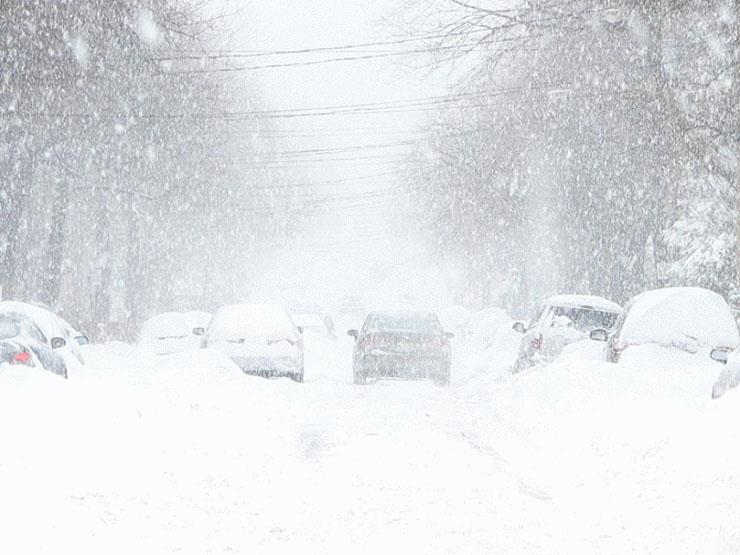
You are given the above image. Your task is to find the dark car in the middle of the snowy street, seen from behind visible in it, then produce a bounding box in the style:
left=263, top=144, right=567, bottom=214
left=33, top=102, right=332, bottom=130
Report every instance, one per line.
left=347, top=311, right=453, bottom=385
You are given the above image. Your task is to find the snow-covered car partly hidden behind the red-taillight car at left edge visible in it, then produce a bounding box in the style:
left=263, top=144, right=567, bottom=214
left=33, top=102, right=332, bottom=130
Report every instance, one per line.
left=0, top=301, right=88, bottom=370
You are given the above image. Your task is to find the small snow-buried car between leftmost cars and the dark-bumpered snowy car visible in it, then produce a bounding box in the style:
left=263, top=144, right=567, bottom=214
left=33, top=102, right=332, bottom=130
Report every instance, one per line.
left=139, top=312, right=200, bottom=355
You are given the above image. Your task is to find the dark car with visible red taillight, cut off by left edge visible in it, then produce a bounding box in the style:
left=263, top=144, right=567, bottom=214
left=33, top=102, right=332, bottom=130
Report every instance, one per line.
left=0, top=310, right=67, bottom=378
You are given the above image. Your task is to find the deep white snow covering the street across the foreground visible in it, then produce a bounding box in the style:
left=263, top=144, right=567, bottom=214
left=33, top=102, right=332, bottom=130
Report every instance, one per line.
left=0, top=332, right=740, bottom=553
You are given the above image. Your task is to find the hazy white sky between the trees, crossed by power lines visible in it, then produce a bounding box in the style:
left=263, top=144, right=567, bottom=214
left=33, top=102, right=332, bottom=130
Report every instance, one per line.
left=214, top=0, right=450, bottom=306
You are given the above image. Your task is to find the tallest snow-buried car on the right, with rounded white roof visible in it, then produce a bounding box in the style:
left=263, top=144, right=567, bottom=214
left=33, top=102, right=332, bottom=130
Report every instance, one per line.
left=591, top=287, right=740, bottom=362
